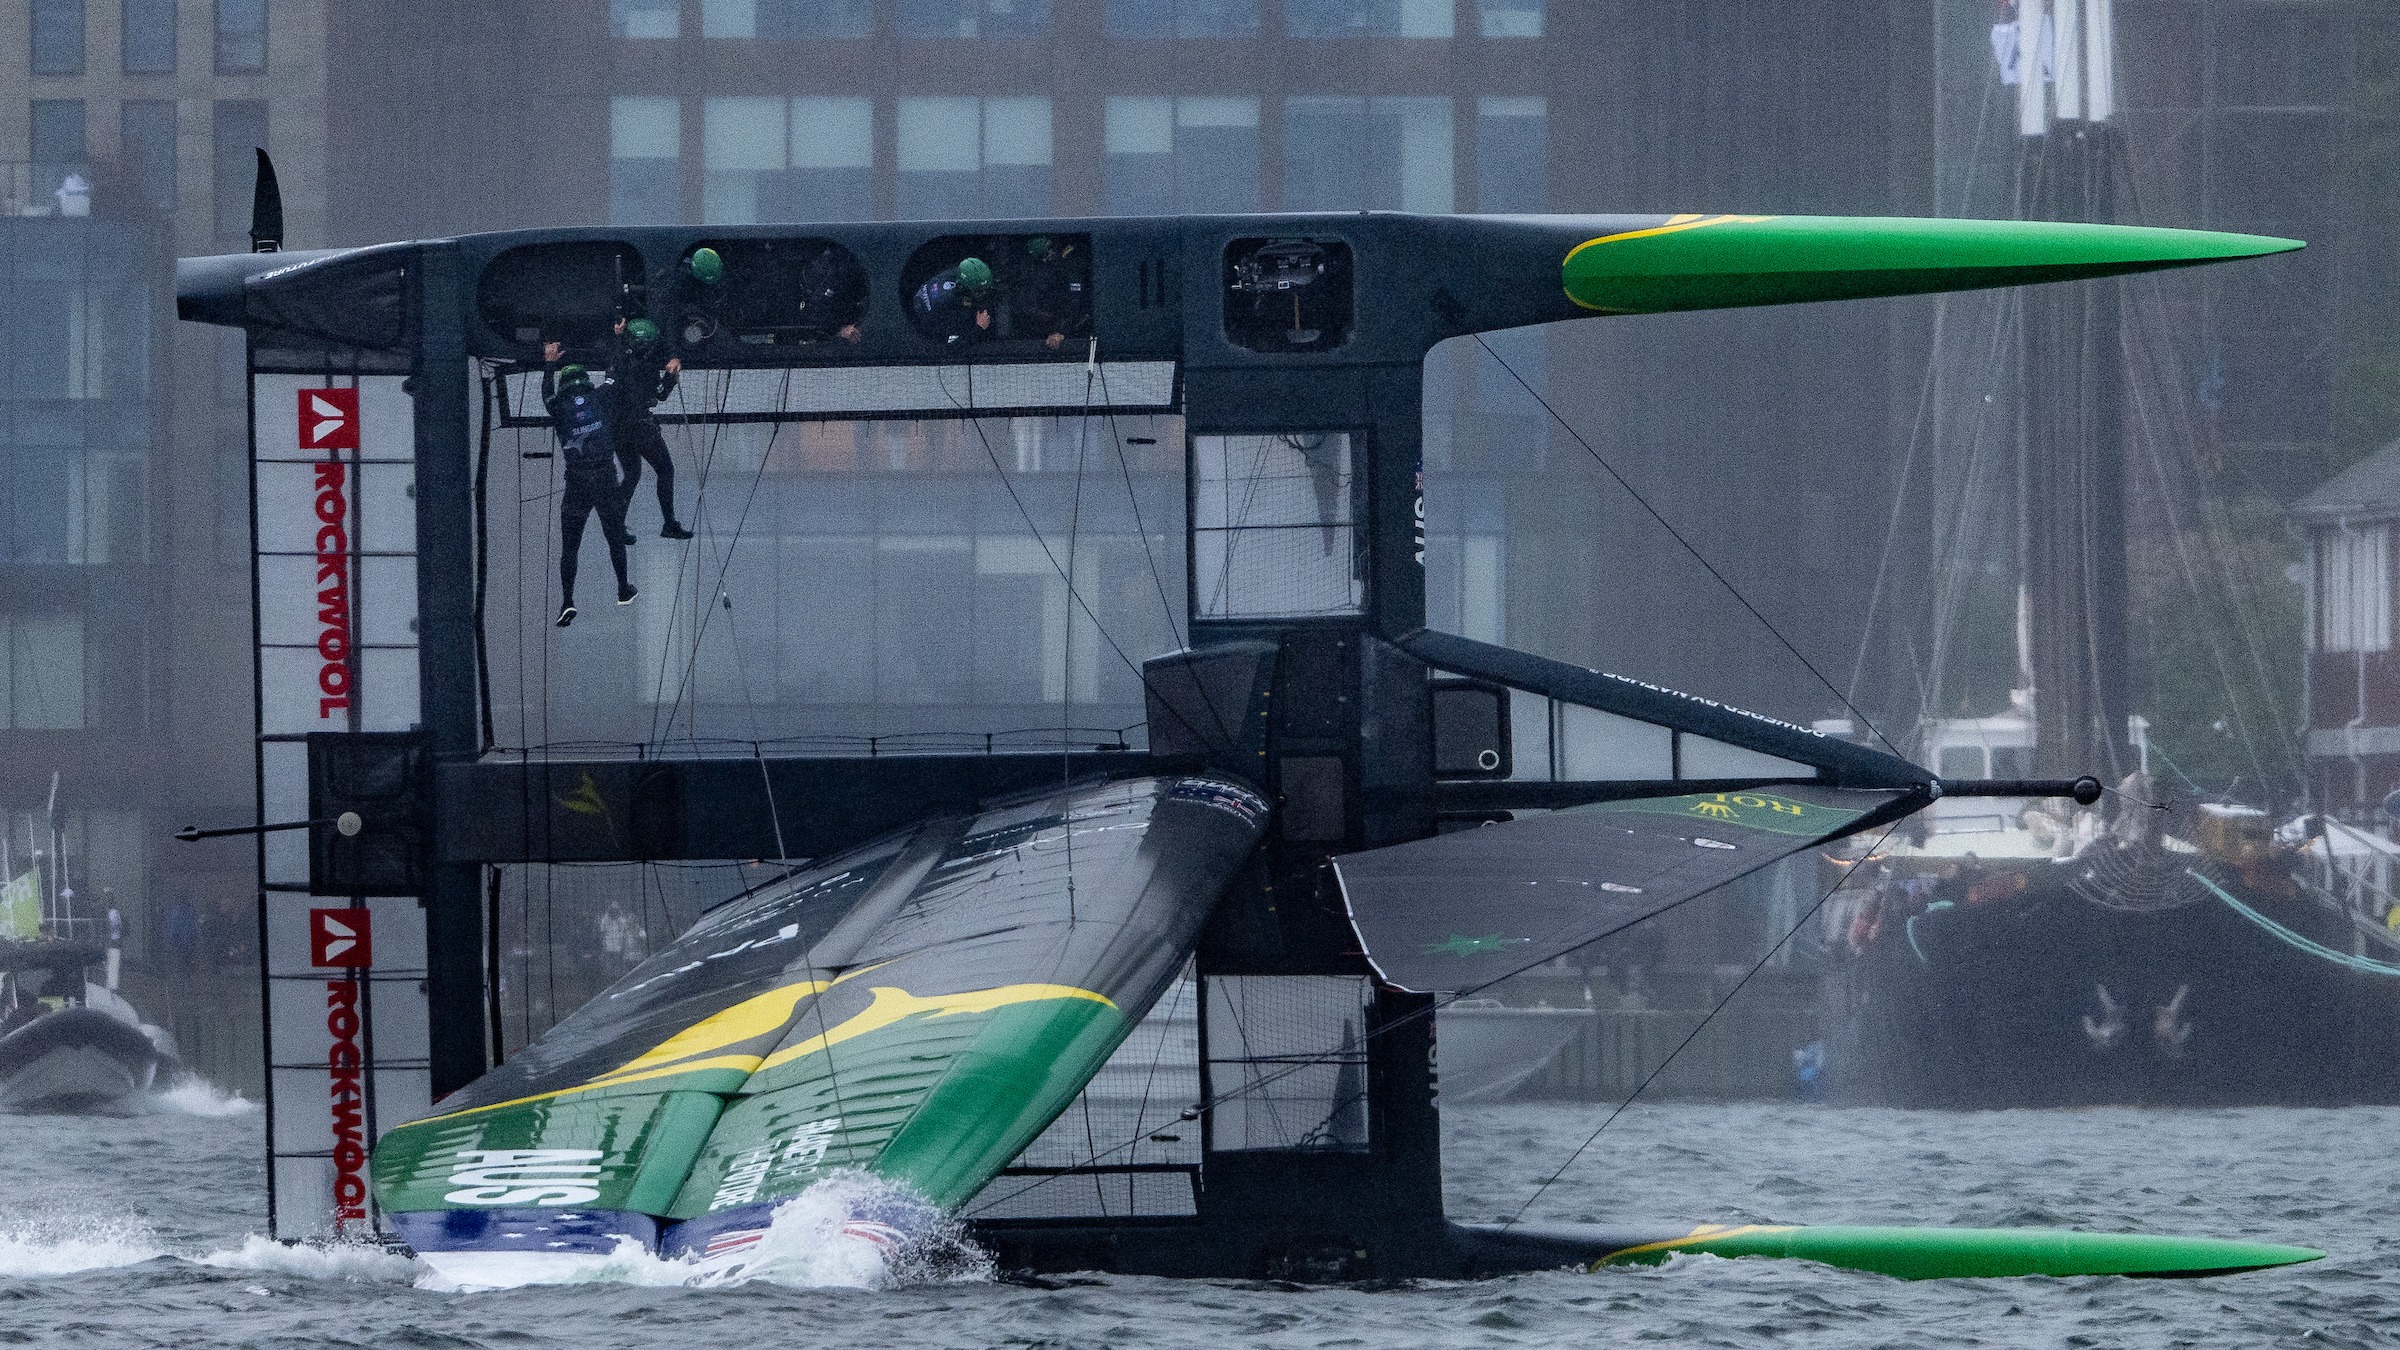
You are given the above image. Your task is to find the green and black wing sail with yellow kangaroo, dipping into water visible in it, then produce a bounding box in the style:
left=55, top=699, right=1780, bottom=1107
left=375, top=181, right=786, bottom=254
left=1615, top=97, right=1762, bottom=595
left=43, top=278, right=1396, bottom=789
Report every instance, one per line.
left=374, top=778, right=1267, bottom=1254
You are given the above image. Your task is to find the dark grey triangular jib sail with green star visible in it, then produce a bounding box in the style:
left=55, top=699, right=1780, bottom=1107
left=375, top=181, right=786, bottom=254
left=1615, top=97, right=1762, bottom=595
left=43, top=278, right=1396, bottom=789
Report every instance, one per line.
left=1334, top=785, right=1915, bottom=992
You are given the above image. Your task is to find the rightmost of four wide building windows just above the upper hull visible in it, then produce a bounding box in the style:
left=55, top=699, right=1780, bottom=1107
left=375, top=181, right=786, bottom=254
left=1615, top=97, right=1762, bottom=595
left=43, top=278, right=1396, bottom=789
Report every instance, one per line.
left=1284, top=96, right=1457, bottom=214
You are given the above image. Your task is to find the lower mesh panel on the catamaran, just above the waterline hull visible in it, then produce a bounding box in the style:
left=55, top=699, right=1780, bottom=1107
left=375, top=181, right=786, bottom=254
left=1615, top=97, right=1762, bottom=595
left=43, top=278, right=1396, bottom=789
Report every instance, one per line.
left=1207, top=975, right=1373, bottom=1153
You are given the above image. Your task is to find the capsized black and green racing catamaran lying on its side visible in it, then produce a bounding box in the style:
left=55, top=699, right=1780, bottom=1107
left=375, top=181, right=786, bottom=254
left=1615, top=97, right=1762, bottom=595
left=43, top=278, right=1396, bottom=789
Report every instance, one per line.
left=178, top=152, right=2314, bottom=1283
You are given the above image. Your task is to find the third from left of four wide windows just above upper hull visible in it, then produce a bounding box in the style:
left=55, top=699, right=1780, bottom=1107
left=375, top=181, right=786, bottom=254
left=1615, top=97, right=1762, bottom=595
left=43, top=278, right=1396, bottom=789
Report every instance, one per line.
left=1102, top=96, right=1258, bottom=216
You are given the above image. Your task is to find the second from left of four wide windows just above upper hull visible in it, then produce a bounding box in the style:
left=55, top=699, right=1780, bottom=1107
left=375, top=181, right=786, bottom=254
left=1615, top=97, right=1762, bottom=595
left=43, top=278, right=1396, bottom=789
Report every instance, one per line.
left=895, top=98, right=1051, bottom=221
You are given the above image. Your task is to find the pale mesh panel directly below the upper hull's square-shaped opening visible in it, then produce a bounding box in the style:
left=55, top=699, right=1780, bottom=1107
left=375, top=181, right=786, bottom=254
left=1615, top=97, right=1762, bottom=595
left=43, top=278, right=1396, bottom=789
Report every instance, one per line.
left=1193, top=432, right=1366, bottom=617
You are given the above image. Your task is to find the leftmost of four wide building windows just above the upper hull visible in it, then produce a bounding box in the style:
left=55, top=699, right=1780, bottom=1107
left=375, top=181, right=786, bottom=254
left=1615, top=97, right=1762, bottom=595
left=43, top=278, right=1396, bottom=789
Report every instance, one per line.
left=701, top=96, right=873, bottom=226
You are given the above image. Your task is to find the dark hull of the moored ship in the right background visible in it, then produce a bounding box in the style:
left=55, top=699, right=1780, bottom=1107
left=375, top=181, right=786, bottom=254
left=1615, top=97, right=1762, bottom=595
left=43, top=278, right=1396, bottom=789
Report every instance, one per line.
left=1826, top=884, right=2400, bottom=1107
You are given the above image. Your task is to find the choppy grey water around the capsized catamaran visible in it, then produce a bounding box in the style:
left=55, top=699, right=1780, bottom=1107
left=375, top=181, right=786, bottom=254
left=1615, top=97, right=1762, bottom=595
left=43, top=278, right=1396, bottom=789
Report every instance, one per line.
left=0, top=1093, right=2400, bottom=1350
